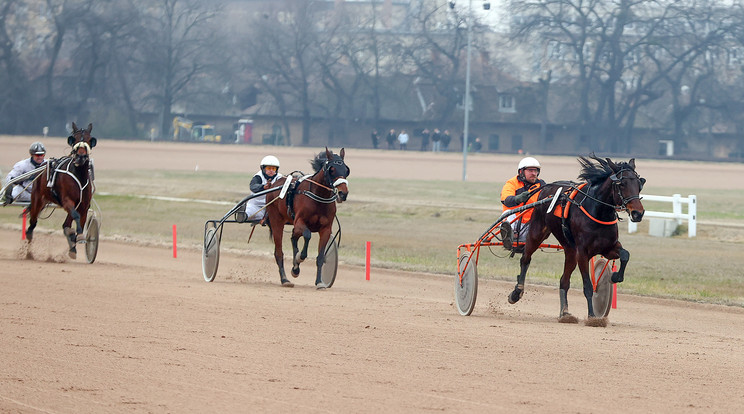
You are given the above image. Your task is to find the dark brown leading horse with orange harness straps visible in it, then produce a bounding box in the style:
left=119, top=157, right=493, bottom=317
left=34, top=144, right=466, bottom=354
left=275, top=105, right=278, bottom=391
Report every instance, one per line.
left=509, top=154, right=646, bottom=324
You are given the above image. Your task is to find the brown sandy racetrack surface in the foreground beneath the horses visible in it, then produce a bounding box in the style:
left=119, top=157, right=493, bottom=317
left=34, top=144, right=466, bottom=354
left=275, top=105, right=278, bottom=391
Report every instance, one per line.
left=0, top=137, right=744, bottom=413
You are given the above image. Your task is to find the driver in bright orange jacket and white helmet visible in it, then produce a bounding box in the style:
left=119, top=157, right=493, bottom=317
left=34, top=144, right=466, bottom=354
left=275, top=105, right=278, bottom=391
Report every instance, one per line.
left=500, top=157, right=545, bottom=251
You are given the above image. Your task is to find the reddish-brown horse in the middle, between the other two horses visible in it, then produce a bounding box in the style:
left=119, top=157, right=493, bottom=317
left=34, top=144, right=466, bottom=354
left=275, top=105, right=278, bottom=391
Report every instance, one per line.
left=266, top=148, right=350, bottom=289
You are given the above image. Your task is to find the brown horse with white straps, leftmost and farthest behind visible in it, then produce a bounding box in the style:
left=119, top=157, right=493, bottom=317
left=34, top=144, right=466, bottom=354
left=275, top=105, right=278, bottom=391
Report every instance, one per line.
left=26, top=122, right=97, bottom=259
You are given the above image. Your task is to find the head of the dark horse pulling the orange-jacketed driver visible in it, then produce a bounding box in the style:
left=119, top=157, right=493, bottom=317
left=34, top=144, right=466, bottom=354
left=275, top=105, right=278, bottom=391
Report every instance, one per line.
left=606, top=158, right=646, bottom=223
